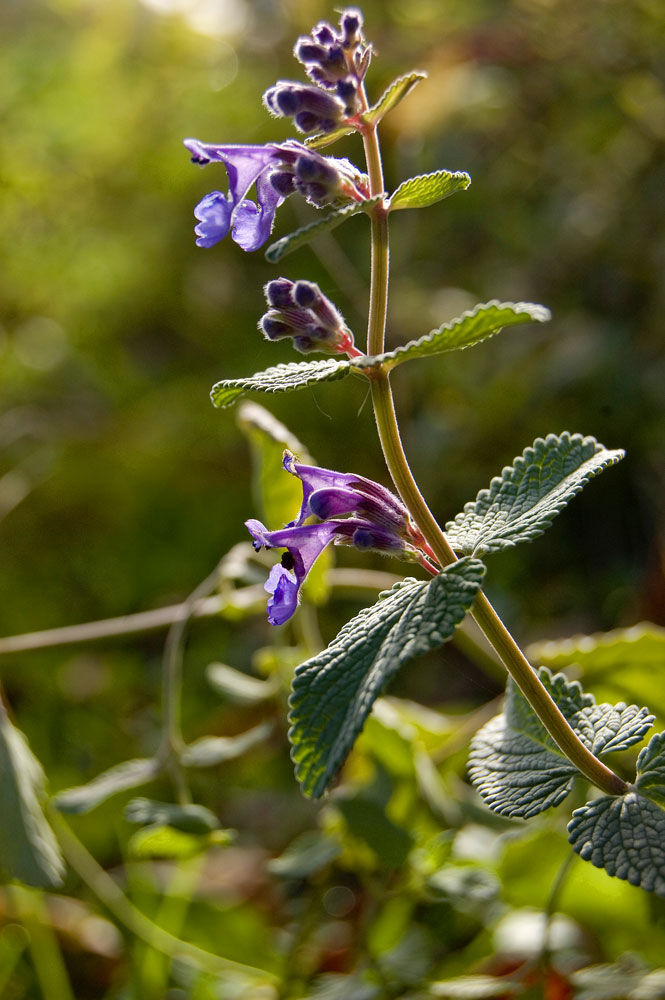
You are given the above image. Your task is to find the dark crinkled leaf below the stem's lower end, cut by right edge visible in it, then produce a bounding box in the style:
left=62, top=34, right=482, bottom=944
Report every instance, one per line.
left=568, top=792, right=665, bottom=896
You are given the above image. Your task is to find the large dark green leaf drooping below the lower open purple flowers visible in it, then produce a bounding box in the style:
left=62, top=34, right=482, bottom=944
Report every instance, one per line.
left=290, top=559, right=485, bottom=798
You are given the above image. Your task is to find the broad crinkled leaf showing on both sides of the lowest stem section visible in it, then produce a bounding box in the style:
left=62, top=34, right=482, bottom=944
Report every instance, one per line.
left=469, top=667, right=653, bottom=819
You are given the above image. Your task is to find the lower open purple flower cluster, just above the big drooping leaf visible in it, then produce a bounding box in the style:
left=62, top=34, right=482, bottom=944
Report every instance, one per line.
left=245, top=451, right=436, bottom=625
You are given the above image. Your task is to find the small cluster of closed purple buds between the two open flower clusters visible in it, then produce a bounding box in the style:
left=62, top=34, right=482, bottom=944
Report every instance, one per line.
left=259, top=278, right=360, bottom=357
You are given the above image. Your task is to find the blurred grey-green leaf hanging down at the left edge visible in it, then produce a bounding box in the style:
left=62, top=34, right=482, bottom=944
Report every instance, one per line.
left=0, top=705, right=65, bottom=889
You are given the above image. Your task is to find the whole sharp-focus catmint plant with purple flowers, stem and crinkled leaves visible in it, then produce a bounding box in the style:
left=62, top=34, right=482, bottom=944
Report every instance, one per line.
left=185, top=9, right=665, bottom=895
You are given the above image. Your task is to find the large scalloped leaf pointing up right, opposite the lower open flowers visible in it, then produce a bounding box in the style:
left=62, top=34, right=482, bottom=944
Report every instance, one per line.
left=446, top=431, right=624, bottom=555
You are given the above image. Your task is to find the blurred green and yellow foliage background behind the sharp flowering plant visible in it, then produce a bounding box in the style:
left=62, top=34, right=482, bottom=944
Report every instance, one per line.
left=0, top=0, right=665, bottom=1000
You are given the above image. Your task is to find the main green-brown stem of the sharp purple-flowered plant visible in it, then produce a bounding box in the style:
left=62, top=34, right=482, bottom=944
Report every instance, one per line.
left=362, top=109, right=628, bottom=795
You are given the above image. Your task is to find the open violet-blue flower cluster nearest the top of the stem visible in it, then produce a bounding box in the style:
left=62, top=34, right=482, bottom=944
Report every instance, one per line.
left=185, top=139, right=368, bottom=251
